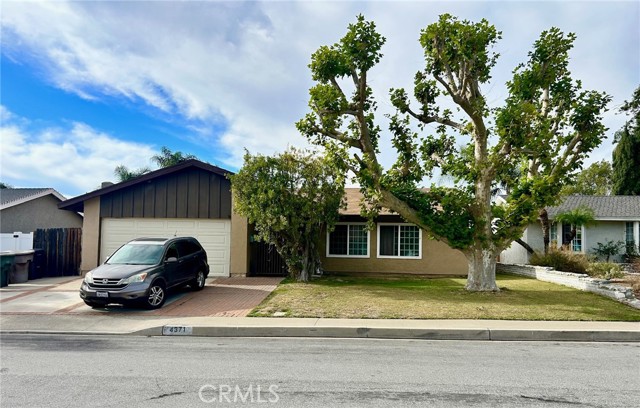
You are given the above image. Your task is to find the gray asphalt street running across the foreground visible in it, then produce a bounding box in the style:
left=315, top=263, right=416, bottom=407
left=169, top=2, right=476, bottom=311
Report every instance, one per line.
left=0, top=334, right=640, bottom=407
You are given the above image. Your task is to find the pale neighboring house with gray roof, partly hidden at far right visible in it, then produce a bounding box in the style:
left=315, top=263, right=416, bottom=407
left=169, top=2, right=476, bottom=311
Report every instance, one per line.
left=500, top=195, right=640, bottom=263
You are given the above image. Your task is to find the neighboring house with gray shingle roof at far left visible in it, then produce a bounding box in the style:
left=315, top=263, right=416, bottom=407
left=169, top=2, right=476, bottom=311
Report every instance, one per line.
left=0, top=188, right=83, bottom=234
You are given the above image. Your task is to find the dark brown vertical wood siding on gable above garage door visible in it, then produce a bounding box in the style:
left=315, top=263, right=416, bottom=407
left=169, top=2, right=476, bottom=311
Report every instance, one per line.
left=100, top=168, right=231, bottom=219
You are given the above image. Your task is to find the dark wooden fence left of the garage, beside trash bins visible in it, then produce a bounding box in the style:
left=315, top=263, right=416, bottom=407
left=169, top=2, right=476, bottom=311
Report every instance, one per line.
left=33, top=228, right=82, bottom=278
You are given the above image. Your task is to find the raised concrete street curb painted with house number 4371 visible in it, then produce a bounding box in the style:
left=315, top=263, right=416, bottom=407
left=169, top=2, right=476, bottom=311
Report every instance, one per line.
left=129, top=325, right=640, bottom=342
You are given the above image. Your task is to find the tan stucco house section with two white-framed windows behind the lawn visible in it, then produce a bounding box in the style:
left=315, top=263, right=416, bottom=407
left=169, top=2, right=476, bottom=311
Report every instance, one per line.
left=321, top=188, right=468, bottom=275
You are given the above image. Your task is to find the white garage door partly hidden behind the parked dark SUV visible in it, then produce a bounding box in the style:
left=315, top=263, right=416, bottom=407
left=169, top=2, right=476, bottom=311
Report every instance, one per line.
left=100, top=218, right=231, bottom=276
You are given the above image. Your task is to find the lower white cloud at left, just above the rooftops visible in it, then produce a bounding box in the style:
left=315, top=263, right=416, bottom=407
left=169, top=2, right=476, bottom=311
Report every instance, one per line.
left=0, top=107, right=156, bottom=196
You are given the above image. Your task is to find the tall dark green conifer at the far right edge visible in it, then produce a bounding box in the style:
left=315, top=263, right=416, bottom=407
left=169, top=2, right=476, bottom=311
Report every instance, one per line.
left=613, top=87, right=640, bottom=195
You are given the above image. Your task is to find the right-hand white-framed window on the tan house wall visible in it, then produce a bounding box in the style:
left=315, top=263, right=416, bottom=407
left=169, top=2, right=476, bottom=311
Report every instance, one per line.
left=378, top=224, right=422, bottom=258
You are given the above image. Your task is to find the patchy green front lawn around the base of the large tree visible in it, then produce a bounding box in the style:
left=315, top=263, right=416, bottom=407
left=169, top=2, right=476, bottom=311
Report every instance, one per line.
left=249, top=275, right=640, bottom=321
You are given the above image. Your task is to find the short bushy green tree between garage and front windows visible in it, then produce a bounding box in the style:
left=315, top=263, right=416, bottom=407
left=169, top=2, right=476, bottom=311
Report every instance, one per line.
left=230, top=149, right=344, bottom=281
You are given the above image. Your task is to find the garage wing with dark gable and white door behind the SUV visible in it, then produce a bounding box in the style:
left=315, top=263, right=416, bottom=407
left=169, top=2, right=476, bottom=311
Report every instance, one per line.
left=59, top=160, right=248, bottom=276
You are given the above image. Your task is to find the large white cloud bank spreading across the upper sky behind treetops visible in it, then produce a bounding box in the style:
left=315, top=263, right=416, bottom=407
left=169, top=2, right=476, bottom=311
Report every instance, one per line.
left=2, top=1, right=640, bottom=182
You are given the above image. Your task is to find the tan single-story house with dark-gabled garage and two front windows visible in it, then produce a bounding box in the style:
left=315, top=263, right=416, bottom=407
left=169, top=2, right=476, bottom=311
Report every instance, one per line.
left=59, top=160, right=467, bottom=276
